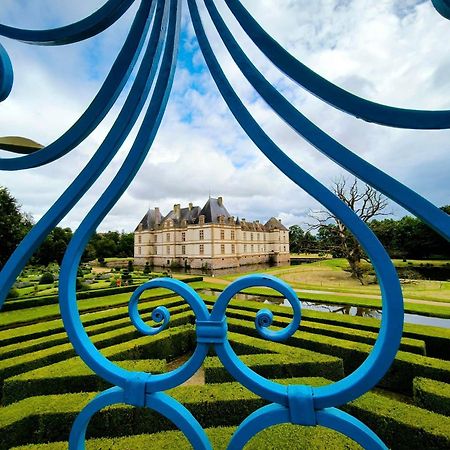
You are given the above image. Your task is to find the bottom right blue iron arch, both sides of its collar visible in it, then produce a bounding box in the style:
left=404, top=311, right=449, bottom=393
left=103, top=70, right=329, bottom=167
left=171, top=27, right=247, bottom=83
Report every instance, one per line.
left=228, top=403, right=387, bottom=450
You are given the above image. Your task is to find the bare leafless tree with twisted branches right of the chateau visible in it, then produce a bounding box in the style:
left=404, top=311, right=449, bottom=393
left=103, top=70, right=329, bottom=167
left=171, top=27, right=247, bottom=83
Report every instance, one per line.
left=310, top=177, right=388, bottom=284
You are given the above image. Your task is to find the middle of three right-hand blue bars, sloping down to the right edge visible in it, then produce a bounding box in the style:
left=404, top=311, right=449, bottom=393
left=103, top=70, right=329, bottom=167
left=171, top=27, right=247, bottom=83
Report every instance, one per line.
left=204, top=0, right=450, bottom=239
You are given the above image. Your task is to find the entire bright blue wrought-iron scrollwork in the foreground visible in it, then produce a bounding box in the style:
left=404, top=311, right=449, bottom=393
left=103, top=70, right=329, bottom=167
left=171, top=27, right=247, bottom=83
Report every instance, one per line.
left=0, top=0, right=450, bottom=449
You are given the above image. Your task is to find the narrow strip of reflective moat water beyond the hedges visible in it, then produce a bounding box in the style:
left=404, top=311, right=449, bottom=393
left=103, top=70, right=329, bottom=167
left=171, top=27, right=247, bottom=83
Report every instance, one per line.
left=200, top=289, right=450, bottom=328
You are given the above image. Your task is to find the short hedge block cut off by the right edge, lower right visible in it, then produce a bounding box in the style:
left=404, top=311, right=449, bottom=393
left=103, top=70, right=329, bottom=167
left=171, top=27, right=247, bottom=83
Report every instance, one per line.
left=413, top=377, right=450, bottom=414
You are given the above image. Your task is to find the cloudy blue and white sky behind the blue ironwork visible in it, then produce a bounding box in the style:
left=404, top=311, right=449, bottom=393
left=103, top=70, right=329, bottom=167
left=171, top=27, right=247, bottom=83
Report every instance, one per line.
left=0, top=0, right=450, bottom=231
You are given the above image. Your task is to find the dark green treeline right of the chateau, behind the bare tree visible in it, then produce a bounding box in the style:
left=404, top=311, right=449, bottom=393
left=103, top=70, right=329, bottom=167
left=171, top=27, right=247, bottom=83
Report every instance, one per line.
left=289, top=206, right=450, bottom=259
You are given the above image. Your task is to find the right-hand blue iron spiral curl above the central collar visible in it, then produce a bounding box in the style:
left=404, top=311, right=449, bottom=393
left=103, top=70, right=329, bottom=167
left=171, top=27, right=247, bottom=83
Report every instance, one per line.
left=211, top=274, right=302, bottom=342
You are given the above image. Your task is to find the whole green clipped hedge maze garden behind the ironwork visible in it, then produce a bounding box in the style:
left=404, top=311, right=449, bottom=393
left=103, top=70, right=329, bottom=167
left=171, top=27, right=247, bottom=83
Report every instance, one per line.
left=0, top=282, right=450, bottom=450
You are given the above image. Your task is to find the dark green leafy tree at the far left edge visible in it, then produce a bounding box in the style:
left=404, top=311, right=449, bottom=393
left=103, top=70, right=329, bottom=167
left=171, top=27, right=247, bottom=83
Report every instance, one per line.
left=0, top=187, right=33, bottom=268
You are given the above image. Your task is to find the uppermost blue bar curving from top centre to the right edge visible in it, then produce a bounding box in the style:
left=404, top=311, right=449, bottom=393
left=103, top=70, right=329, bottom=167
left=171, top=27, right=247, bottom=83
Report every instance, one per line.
left=221, top=0, right=450, bottom=130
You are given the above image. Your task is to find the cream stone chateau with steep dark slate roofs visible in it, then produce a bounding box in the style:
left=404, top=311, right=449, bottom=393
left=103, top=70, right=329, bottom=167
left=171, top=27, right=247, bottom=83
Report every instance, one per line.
left=134, top=197, right=290, bottom=269
